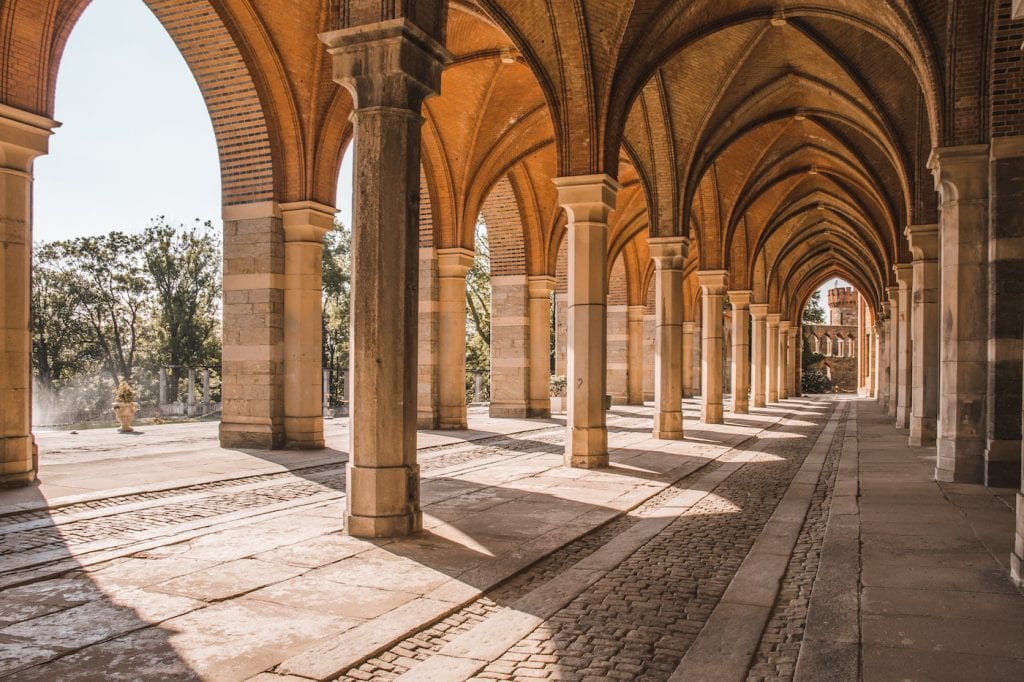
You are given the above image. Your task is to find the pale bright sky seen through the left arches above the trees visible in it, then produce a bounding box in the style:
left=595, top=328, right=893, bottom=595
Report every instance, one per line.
left=34, top=0, right=352, bottom=242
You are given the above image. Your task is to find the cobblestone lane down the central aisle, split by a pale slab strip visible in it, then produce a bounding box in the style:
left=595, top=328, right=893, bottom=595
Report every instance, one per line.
left=340, top=401, right=842, bottom=680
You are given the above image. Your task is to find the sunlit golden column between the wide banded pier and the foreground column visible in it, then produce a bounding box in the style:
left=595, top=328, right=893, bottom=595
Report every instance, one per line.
left=281, top=202, right=336, bottom=450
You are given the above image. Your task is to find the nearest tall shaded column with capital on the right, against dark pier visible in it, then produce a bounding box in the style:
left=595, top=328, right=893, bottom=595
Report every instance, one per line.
left=929, top=144, right=989, bottom=483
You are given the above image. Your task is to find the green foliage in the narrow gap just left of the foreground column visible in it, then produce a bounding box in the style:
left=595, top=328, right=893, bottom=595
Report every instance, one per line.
left=323, top=222, right=352, bottom=403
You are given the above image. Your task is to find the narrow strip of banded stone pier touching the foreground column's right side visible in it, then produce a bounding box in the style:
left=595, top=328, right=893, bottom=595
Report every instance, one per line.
left=416, top=247, right=440, bottom=430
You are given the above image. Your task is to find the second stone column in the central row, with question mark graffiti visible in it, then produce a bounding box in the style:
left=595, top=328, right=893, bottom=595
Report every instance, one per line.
left=555, top=175, right=620, bottom=469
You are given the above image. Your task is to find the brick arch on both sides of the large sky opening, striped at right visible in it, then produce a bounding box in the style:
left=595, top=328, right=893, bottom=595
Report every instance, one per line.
left=0, top=0, right=275, bottom=205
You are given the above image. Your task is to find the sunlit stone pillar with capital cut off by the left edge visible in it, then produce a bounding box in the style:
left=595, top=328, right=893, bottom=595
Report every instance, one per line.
left=0, top=104, right=60, bottom=487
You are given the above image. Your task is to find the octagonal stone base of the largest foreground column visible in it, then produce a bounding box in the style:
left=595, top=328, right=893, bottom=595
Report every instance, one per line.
left=345, top=463, right=423, bottom=538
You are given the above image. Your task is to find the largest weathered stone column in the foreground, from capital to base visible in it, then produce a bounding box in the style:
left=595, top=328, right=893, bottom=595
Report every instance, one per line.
left=321, top=19, right=452, bottom=538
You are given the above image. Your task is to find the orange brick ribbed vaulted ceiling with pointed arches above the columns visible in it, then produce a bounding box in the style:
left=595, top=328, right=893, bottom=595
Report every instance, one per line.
left=0, top=0, right=995, bottom=310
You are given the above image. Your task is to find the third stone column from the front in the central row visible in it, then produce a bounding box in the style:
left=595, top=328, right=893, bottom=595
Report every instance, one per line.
left=648, top=237, right=690, bottom=440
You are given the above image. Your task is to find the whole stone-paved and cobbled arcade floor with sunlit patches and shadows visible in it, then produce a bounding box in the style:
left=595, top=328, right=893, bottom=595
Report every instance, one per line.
left=0, top=398, right=1024, bottom=682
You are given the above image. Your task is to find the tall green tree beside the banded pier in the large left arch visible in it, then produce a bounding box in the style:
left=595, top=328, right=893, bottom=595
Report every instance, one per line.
left=142, top=216, right=221, bottom=397
